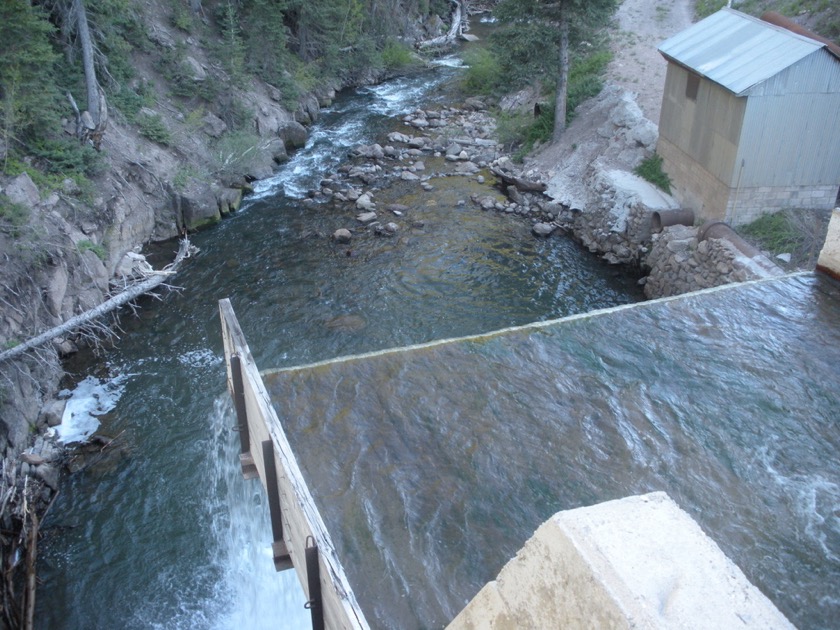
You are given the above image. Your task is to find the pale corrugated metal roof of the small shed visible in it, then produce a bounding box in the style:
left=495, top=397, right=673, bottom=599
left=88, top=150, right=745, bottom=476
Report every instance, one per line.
left=659, top=9, right=825, bottom=94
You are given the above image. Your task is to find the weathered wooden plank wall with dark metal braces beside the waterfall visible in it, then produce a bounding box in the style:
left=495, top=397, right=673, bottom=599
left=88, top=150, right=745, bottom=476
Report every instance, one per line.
left=219, top=299, right=369, bottom=629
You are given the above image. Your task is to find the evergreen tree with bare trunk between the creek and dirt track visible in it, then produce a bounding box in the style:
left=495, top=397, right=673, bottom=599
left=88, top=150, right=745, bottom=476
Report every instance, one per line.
left=494, top=0, right=618, bottom=140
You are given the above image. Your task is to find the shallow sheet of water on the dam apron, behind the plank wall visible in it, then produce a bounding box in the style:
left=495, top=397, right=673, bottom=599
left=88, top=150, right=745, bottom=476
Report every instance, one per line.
left=264, top=274, right=840, bottom=628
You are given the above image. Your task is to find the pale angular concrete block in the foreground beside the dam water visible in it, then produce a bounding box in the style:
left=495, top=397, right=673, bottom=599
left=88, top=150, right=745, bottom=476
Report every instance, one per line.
left=448, top=492, right=793, bottom=630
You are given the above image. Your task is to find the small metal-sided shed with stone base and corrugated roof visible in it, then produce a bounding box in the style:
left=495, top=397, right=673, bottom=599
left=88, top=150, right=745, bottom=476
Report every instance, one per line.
left=657, top=9, right=840, bottom=224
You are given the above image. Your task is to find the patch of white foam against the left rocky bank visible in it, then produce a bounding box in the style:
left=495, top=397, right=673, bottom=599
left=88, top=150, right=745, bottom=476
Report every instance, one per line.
left=55, top=374, right=131, bottom=444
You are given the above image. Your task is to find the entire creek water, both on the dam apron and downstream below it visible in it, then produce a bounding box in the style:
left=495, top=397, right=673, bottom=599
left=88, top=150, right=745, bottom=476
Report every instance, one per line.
left=36, top=55, right=840, bottom=630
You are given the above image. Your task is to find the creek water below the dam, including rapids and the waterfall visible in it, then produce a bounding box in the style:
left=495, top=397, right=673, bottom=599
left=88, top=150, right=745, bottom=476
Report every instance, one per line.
left=36, top=67, right=641, bottom=629
